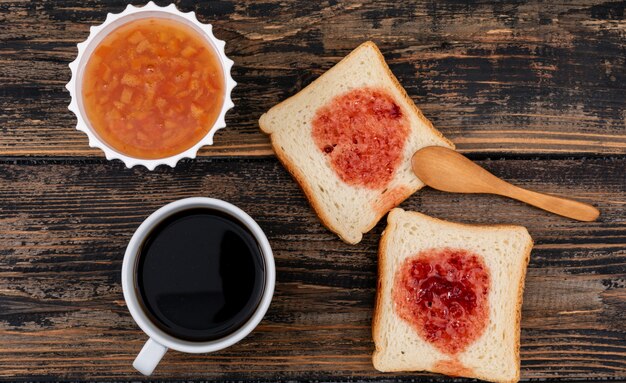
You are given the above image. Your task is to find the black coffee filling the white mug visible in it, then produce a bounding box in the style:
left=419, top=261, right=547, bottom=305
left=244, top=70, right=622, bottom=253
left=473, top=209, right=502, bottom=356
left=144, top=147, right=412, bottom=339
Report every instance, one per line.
left=135, top=208, right=265, bottom=341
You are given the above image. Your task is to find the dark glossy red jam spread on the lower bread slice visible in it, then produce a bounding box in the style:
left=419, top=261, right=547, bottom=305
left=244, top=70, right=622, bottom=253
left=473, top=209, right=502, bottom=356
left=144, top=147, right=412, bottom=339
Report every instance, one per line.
left=393, top=248, right=490, bottom=354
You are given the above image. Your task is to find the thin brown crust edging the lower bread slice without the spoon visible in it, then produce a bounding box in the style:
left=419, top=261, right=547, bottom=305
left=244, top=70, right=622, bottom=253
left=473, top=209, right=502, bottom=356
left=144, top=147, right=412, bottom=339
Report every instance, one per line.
left=372, top=208, right=533, bottom=383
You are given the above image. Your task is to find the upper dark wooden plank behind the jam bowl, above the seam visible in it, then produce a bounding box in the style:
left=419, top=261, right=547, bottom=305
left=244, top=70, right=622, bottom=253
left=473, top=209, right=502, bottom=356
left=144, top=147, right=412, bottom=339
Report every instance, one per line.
left=0, top=0, right=626, bottom=157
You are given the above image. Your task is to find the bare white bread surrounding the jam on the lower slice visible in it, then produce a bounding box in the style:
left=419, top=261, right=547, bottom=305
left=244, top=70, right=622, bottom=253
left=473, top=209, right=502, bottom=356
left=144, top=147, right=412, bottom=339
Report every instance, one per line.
left=372, top=209, right=533, bottom=382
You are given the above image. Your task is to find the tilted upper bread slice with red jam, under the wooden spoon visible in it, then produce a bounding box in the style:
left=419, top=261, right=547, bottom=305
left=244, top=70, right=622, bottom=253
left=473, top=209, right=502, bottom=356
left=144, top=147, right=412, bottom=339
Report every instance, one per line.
left=259, top=42, right=454, bottom=244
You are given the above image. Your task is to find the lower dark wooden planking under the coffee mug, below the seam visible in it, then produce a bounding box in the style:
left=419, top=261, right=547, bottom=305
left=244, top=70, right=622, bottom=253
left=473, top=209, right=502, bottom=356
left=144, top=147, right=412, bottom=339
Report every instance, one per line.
left=0, top=157, right=626, bottom=381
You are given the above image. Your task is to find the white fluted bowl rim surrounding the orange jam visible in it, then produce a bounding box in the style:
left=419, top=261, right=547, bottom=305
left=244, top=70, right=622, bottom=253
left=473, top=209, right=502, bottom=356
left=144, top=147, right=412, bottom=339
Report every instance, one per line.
left=65, top=1, right=237, bottom=170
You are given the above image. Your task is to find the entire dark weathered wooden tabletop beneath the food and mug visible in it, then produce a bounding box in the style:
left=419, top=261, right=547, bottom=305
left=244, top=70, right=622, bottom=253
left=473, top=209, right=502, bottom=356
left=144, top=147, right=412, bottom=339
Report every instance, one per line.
left=0, top=0, right=626, bottom=381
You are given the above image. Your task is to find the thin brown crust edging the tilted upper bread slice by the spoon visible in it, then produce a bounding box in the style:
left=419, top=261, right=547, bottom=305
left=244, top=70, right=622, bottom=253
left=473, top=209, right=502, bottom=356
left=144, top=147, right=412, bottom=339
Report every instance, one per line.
left=259, top=41, right=455, bottom=245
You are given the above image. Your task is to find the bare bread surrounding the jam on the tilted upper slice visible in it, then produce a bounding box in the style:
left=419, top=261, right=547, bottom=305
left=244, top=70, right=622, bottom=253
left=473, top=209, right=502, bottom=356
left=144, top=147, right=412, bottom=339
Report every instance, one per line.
left=259, top=42, right=454, bottom=244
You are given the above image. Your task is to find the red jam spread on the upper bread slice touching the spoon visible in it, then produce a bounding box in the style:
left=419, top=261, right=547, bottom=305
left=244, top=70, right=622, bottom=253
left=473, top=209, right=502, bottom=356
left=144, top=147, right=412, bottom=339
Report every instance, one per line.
left=312, top=88, right=409, bottom=189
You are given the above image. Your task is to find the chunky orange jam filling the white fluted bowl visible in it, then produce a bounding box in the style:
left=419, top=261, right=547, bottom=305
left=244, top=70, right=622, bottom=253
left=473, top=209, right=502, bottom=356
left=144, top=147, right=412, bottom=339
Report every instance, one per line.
left=82, top=17, right=225, bottom=159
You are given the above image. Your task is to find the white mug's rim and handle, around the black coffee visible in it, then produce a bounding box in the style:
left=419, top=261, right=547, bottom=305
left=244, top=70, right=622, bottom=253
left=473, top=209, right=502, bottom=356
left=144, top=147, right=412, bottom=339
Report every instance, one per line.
left=122, top=197, right=276, bottom=375
